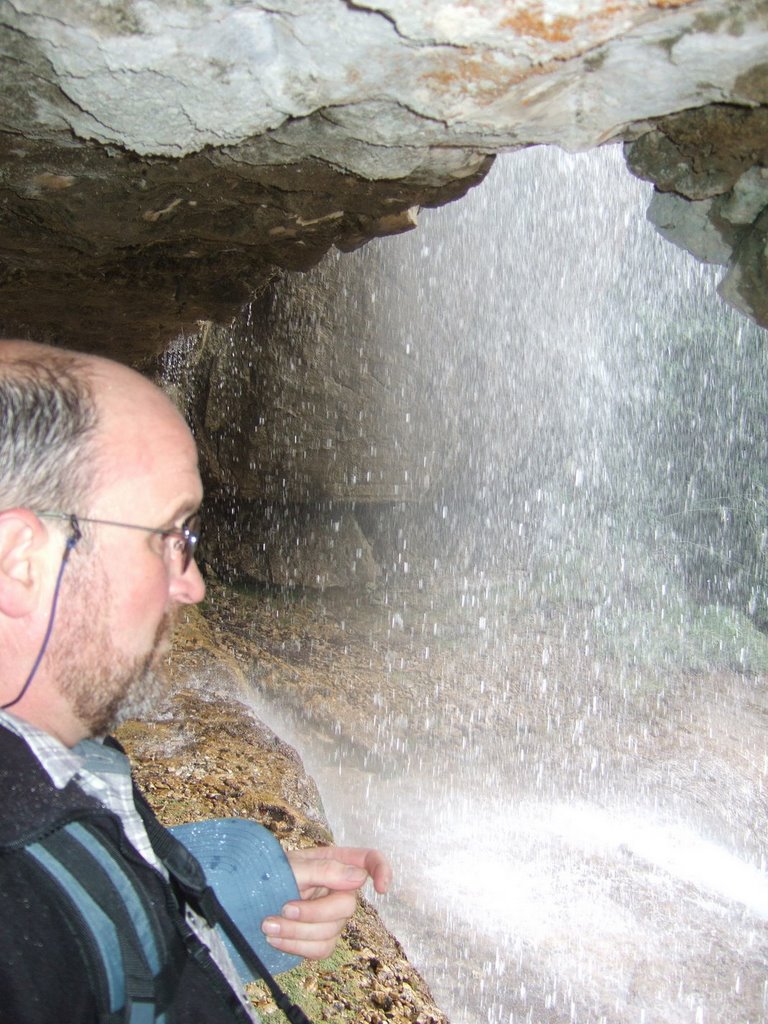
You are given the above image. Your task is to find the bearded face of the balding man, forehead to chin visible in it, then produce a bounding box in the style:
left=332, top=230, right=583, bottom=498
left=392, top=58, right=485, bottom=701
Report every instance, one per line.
left=48, top=368, right=205, bottom=735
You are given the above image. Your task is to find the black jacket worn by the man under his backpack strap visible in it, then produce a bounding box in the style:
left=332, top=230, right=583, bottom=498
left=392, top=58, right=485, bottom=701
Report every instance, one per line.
left=0, top=727, right=256, bottom=1024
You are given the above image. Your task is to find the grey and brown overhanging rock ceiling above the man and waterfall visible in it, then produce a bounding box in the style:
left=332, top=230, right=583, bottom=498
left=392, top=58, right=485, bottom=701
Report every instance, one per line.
left=0, top=0, right=768, bottom=365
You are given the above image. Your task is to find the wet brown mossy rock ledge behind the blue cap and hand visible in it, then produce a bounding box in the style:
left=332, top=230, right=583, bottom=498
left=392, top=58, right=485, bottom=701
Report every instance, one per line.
left=119, top=611, right=447, bottom=1024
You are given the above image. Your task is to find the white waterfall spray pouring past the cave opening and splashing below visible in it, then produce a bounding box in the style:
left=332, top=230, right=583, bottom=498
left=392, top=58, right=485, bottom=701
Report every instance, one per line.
left=195, top=150, right=768, bottom=1024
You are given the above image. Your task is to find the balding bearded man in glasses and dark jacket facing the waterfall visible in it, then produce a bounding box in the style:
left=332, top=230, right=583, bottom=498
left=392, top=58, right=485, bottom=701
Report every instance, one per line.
left=0, top=341, right=391, bottom=1024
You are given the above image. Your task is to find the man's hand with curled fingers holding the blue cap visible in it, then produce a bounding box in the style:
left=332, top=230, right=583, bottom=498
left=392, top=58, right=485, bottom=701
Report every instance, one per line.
left=261, top=846, right=392, bottom=959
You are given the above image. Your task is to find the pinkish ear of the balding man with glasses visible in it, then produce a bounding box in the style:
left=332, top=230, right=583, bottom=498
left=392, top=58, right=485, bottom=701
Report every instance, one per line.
left=0, top=509, right=50, bottom=618
